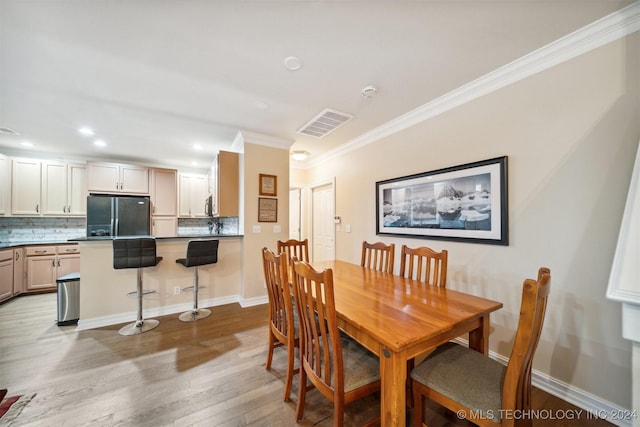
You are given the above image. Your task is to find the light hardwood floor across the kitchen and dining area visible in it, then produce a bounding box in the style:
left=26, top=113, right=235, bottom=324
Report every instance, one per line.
left=0, top=294, right=606, bottom=427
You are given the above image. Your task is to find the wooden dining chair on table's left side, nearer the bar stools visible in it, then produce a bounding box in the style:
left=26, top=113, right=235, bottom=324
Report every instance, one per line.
left=262, top=248, right=300, bottom=401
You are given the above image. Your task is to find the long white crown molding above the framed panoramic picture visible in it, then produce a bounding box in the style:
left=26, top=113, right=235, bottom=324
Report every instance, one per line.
left=305, top=1, right=640, bottom=168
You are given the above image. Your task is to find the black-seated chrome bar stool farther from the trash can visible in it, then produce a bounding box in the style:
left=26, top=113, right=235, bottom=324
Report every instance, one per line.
left=176, top=240, right=220, bottom=322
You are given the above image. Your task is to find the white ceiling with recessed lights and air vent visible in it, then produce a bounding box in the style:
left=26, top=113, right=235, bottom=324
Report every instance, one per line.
left=0, top=0, right=632, bottom=169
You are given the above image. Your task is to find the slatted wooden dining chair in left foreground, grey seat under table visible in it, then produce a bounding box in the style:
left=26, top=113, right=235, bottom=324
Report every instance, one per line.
left=293, top=259, right=380, bottom=426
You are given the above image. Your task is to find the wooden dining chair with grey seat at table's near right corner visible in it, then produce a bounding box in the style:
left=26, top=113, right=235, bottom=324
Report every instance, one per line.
left=411, top=267, right=551, bottom=427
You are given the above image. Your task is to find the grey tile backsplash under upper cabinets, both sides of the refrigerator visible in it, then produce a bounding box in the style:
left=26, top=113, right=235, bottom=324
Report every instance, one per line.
left=0, top=217, right=238, bottom=243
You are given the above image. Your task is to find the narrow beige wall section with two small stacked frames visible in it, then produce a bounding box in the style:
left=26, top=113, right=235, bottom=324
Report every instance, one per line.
left=241, top=141, right=289, bottom=301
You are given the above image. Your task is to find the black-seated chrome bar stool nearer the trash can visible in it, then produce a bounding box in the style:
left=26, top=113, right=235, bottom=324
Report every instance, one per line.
left=113, top=237, right=162, bottom=335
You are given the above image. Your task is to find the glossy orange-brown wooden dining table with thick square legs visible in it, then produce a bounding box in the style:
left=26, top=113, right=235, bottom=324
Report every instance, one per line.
left=312, top=260, right=502, bottom=427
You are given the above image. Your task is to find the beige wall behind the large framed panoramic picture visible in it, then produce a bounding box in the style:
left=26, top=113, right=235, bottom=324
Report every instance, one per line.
left=292, top=33, right=640, bottom=408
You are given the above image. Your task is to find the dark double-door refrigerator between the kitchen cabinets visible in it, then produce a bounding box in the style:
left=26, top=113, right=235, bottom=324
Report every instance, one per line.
left=87, top=194, right=151, bottom=237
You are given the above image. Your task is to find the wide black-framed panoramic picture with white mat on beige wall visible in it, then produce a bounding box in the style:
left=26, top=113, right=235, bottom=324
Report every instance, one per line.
left=376, top=156, right=509, bottom=245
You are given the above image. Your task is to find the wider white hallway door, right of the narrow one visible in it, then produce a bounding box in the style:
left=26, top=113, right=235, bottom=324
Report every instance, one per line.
left=311, top=183, right=336, bottom=261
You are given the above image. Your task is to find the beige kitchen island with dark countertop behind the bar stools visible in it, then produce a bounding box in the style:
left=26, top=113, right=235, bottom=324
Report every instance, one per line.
left=71, top=234, right=242, bottom=330
